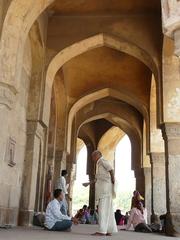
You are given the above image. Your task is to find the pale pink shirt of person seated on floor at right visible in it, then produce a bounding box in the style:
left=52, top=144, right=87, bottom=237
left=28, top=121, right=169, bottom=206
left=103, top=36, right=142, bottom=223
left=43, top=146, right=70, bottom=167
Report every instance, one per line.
left=126, top=208, right=147, bottom=230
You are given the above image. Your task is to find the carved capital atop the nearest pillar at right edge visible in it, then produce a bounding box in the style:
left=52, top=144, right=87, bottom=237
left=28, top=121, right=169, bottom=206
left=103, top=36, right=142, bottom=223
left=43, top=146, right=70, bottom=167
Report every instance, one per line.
left=162, top=122, right=180, bottom=140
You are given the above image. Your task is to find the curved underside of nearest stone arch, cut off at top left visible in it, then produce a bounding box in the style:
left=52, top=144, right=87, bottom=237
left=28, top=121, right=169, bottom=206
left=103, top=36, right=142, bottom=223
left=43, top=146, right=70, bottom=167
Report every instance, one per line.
left=0, top=0, right=54, bottom=89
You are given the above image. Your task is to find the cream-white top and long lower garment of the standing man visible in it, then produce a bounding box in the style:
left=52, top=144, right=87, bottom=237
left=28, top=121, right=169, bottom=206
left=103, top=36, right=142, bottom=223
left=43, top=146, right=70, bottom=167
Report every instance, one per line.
left=96, top=158, right=117, bottom=234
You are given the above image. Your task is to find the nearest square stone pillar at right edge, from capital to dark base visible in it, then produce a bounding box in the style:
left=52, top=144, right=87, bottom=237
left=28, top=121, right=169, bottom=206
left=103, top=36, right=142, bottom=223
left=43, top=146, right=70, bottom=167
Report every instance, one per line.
left=162, top=122, right=180, bottom=236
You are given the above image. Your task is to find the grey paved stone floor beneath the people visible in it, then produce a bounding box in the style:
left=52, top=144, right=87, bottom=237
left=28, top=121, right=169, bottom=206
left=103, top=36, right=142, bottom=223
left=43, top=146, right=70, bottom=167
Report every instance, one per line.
left=0, top=225, right=180, bottom=240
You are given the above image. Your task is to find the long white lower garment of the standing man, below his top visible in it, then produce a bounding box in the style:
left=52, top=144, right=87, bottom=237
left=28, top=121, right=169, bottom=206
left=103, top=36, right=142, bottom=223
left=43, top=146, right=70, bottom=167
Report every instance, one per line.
left=98, top=197, right=117, bottom=234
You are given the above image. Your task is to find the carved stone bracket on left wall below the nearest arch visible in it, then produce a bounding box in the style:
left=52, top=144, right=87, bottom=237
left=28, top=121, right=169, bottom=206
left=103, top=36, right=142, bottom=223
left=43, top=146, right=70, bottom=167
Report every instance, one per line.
left=0, top=82, right=17, bottom=110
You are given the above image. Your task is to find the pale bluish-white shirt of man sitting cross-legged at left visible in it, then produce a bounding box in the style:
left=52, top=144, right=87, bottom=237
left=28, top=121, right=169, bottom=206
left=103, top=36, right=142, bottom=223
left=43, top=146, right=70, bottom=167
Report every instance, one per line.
left=44, top=199, right=71, bottom=229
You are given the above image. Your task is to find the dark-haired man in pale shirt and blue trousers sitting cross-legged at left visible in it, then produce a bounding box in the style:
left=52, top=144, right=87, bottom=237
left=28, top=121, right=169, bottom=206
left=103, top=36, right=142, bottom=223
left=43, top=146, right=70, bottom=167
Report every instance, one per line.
left=44, top=189, right=78, bottom=231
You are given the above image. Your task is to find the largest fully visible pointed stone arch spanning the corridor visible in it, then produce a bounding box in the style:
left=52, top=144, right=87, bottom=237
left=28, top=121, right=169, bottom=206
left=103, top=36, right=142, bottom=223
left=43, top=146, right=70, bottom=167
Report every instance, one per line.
left=42, top=33, right=159, bottom=125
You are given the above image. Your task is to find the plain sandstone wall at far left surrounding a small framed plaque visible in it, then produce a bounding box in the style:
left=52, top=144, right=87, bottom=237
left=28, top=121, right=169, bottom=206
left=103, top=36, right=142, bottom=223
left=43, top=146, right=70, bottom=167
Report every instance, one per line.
left=0, top=35, right=31, bottom=224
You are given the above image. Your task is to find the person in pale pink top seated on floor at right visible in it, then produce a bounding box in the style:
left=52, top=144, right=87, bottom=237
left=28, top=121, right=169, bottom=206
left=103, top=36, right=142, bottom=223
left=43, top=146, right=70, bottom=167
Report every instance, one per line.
left=126, top=204, right=152, bottom=233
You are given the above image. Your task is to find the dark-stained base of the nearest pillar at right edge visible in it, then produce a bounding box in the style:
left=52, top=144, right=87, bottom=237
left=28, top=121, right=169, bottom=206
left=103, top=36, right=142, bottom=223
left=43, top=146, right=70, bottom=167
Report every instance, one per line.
left=166, top=213, right=180, bottom=237
